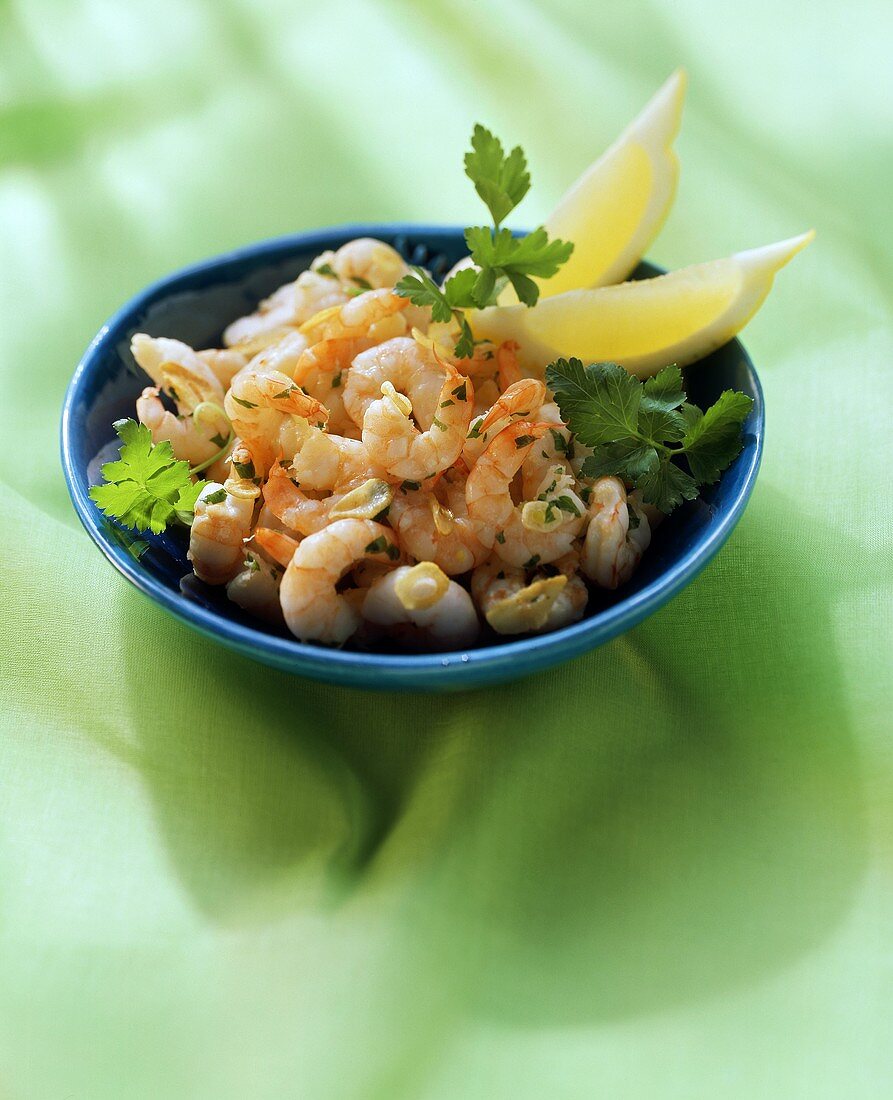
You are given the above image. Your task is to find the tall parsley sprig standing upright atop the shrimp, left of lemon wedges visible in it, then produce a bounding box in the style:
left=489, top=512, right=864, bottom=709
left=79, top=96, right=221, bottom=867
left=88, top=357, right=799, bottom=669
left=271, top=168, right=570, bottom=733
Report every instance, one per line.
left=395, top=123, right=574, bottom=359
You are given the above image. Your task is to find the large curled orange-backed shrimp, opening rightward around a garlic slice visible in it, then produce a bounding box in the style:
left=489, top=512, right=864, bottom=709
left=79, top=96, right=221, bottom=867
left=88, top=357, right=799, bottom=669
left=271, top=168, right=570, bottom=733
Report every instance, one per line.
left=465, top=420, right=584, bottom=569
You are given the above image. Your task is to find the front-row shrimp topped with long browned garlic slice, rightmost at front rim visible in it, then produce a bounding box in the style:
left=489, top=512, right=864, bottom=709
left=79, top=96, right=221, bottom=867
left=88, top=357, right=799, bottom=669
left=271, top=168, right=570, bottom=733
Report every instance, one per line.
left=472, top=559, right=589, bottom=634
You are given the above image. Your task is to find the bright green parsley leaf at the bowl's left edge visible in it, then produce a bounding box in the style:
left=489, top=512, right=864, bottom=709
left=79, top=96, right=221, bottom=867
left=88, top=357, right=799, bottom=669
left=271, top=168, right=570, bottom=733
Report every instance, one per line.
left=90, top=420, right=207, bottom=535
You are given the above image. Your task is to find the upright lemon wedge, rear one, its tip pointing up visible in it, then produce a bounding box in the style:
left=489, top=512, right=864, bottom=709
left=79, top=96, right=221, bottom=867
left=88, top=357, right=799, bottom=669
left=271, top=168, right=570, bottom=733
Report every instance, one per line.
left=499, top=69, right=686, bottom=305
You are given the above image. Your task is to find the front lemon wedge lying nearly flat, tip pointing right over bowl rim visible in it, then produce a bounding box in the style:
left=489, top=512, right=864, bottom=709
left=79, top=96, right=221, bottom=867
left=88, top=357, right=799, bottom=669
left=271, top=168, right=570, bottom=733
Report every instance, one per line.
left=468, top=230, right=815, bottom=378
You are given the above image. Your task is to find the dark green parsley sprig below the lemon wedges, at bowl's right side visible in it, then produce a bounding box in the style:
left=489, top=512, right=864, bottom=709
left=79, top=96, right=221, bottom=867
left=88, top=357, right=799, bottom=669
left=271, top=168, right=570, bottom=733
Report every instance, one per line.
left=545, top=359, right=753, bottom=513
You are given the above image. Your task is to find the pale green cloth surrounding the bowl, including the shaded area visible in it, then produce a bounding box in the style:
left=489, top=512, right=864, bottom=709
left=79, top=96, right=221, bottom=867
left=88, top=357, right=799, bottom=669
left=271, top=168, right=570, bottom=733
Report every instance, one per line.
left=0, top=0, right=893, bottom=1100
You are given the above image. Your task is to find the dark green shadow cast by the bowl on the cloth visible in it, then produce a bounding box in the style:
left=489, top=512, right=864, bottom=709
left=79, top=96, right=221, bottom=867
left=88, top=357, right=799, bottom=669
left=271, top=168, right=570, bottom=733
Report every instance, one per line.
left=104, top=490, right=866, bottom=1023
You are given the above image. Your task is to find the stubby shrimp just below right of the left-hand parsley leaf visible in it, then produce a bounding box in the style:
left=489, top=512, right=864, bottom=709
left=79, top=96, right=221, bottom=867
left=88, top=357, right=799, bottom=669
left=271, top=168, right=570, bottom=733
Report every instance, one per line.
left=188, top=482, right=254, bottom=584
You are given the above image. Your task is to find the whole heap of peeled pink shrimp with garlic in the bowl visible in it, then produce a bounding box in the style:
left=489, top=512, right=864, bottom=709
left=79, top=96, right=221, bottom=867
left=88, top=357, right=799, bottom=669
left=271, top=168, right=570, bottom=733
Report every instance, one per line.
left=132, top=238, right=661, bottom=650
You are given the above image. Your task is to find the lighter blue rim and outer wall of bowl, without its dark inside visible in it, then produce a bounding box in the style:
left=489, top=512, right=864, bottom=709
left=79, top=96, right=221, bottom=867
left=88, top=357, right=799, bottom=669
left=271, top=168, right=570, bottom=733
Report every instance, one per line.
left=59, top=223, right=765, bottom=690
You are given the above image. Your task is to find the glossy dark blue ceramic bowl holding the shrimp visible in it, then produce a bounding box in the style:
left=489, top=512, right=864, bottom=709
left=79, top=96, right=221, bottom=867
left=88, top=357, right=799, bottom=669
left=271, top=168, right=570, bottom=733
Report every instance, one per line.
left=62, top=226, right=764, bottom=691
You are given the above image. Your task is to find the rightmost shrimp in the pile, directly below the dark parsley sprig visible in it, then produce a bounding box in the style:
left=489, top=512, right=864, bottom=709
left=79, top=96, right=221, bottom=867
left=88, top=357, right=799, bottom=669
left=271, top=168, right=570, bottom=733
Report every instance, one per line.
left=582, top=477, right=651, bottom=589
